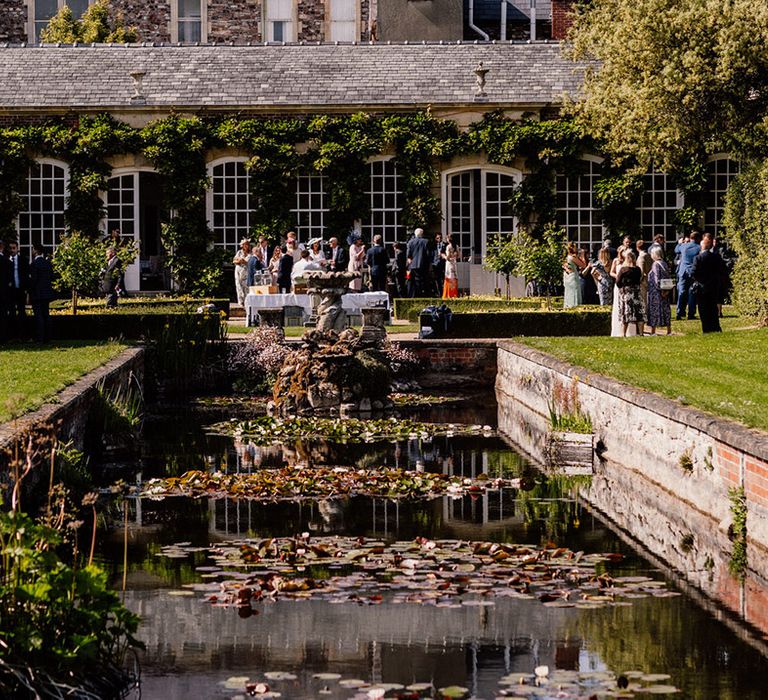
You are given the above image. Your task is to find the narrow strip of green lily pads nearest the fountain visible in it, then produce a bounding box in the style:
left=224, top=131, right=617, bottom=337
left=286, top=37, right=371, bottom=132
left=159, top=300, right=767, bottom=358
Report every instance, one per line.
left=209, top=416, right=494, bottom=445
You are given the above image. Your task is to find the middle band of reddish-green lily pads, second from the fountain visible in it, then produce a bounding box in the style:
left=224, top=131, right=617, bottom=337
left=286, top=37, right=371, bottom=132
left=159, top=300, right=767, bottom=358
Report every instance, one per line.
left=139, top=467, right=520, bottom=502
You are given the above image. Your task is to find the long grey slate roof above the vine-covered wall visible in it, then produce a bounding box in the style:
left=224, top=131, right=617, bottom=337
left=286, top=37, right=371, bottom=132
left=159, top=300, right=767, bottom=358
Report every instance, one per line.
left=0, top=43, right=580, bottom=113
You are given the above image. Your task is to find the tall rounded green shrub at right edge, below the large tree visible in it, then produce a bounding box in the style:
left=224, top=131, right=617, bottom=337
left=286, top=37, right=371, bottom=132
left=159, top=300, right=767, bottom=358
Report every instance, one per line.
left=723, top=161, right=768, bottom=325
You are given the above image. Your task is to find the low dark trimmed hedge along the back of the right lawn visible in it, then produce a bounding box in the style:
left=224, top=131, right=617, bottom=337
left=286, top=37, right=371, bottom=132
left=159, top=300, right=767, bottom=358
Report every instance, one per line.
left=425, top=307, right=611, bottom=338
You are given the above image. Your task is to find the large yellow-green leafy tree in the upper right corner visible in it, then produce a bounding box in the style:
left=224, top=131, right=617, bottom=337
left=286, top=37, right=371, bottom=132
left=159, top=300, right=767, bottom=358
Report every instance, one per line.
left=568, top=0, right=768, bottom=172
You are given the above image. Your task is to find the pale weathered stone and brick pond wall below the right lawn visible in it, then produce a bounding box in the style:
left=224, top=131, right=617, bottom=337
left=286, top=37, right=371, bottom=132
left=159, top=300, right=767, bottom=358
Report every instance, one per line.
left=496, top=341, right=768, bottom=549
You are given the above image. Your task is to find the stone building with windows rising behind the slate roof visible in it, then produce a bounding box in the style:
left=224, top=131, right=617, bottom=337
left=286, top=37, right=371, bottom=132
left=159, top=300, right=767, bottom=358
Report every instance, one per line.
left=0, top=0, right=573, bottom=44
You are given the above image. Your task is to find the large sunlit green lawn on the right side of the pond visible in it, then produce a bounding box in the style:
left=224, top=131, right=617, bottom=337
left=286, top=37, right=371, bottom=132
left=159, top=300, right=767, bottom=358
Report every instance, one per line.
left=517, top=314, right=768, bottom=430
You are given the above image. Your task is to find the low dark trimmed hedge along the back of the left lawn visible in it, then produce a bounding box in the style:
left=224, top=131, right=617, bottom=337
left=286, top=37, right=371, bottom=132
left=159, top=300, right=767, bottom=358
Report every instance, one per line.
left=51, top=312, right=221, bottom=340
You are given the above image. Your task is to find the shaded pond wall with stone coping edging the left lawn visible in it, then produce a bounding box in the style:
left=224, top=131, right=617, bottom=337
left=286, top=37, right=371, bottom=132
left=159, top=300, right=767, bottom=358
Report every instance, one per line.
left=0, top=347, right=144, bottom=451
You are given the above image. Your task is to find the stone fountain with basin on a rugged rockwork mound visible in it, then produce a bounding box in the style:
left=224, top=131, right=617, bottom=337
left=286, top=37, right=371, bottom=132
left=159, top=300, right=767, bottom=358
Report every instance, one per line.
left=270, top=272, right=392, bottom=416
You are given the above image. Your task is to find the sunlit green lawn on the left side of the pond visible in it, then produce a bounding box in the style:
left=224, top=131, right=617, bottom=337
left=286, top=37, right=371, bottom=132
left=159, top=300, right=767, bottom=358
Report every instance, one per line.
left=0, top=340, right=128, bottom=422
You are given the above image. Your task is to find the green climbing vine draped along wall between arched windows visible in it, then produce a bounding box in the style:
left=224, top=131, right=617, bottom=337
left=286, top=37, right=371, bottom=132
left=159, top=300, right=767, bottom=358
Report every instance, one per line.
left=0, top=111, right=641, bottom=292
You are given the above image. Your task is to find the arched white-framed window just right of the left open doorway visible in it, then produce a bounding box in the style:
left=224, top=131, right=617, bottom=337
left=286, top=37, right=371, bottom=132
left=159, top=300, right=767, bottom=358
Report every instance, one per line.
left=208, top=160, right=251, bottom=248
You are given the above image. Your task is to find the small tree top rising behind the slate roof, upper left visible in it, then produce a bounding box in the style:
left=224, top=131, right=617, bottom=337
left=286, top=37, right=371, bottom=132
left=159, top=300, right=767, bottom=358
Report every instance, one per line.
left=40, top=0, right=138, bottom=44
